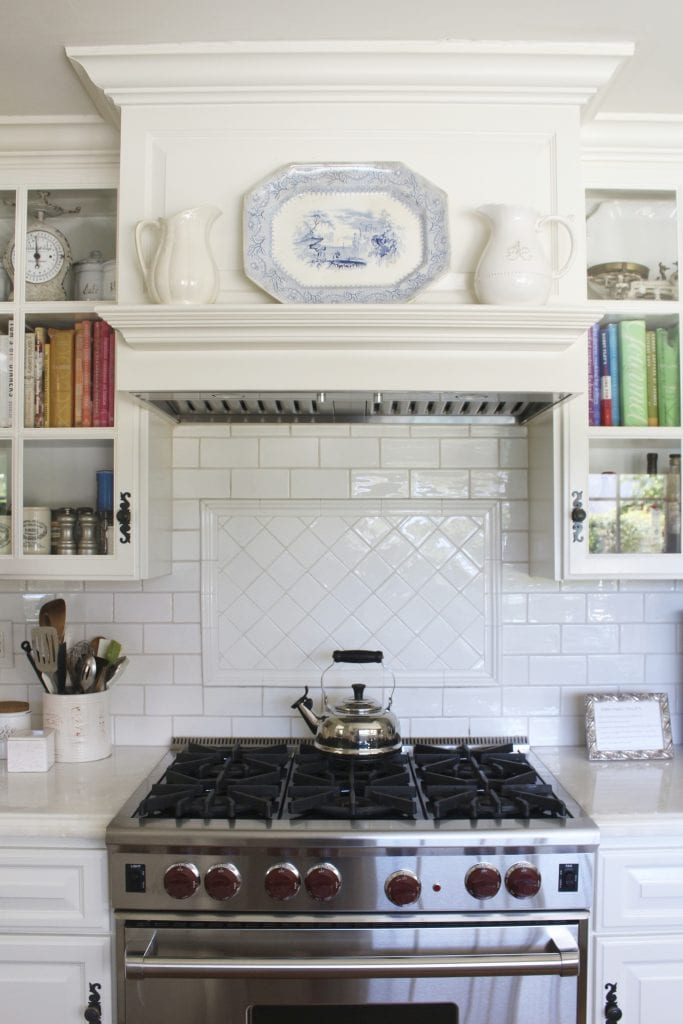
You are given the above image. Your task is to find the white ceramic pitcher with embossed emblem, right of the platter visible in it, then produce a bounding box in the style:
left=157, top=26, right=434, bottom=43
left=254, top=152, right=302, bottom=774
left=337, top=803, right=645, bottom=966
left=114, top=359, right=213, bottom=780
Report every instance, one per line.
left=474, top=203, right=574, bottom=305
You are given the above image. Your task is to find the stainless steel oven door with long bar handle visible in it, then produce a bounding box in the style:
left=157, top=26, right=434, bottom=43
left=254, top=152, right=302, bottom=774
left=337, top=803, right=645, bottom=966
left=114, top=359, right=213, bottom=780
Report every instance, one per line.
left=118, top=919, right=586, bottom=1024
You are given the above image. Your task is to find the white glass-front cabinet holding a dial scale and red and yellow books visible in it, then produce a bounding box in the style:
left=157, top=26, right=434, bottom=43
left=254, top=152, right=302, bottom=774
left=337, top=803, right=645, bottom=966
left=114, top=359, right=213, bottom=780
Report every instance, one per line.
left=0, top=172, right=171, bottom=580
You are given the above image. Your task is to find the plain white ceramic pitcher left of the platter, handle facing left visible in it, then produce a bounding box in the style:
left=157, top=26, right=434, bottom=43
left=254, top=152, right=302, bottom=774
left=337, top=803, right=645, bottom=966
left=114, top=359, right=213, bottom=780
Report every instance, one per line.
left=135, top=206, right=221, bottom=304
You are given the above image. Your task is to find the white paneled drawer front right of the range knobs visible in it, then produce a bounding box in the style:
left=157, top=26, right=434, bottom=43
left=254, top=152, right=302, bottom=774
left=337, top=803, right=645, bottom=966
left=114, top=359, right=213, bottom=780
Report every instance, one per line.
left=597, top=850, right=683, bottom=931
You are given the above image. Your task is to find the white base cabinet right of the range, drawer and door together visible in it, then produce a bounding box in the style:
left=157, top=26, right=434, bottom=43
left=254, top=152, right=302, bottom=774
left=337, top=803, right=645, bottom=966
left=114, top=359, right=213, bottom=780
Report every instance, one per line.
left=589, top=836, right=683, bottom=1024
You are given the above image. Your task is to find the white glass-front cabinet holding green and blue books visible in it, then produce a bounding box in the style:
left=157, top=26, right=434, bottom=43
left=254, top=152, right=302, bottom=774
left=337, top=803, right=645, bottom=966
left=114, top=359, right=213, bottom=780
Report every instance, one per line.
left=562, top=188, right=683, bottom=579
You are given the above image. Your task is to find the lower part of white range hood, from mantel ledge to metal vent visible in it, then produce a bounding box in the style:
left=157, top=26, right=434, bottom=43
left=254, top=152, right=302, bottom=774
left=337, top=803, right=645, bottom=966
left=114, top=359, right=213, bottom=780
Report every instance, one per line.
left=98, top=303, right=594, bottom=422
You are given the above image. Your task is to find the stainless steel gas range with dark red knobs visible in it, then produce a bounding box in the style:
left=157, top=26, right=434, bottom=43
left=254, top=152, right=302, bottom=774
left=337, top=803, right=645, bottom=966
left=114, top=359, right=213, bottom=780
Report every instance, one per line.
left=106, top=738, right=598, bottom=1024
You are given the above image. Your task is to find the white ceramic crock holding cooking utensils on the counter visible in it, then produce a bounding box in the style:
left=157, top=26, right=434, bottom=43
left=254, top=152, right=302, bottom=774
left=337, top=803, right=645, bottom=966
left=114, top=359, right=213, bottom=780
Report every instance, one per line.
left=43, top=690, right=112, bottom=762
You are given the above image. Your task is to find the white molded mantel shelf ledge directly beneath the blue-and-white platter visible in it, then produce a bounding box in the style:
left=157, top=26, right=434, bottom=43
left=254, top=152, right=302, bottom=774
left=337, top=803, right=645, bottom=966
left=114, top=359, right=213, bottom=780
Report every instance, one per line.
left=96, top=303, right=596, bottom=353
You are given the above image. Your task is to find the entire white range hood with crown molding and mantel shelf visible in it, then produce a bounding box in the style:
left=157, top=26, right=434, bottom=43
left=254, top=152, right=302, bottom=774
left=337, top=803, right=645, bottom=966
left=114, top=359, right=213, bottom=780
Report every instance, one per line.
left=68, top=41, right=633, bottom=417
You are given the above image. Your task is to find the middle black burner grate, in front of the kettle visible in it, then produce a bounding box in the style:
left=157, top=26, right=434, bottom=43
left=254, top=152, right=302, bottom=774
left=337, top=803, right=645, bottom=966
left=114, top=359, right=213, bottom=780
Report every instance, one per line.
left=287, top=749, right=417, bottom=820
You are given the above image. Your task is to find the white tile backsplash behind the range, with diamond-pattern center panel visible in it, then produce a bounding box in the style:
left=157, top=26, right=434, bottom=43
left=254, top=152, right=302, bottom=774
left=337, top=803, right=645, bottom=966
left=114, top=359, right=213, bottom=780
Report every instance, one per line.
left=0, top=423, right=683, bottom=756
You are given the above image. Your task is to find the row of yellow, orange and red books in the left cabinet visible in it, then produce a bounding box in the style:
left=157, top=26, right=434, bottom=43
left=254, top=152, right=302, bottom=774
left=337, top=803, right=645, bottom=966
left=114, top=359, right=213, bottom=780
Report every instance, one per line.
left=24, top=321, right=116, bottom=427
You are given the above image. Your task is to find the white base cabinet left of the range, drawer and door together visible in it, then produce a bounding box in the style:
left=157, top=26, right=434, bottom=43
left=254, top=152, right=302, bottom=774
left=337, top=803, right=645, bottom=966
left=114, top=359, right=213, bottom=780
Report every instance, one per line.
left=0, top=848, right=114, bottom=1024
